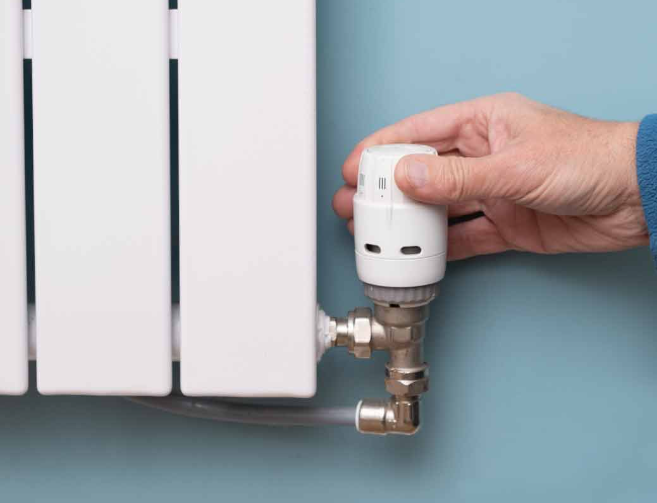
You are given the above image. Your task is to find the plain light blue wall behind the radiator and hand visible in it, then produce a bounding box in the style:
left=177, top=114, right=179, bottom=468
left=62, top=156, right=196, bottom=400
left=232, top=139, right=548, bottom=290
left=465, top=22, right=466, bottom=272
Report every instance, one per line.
left=0, top=0, right=657, bottom=503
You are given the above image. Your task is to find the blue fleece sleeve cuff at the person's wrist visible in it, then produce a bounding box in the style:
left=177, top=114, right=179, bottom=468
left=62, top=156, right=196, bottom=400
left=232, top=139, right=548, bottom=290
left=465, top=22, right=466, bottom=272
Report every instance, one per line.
left=636, top=114, right=657, bottom=265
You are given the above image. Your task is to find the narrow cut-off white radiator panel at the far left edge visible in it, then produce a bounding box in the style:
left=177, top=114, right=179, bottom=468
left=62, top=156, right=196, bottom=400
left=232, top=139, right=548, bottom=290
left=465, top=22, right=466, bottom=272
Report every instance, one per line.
left=0, top=0, right=28, bottom=395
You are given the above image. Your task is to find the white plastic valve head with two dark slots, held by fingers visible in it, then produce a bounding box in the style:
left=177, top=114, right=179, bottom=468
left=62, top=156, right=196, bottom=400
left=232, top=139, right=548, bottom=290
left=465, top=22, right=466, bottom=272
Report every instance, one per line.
left=354, top=145, right=447, bottom=296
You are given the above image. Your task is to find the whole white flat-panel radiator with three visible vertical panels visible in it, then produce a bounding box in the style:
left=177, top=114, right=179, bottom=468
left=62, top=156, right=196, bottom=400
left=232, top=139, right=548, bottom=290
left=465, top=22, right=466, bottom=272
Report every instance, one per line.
left=0, top=0, right=316, bottom=397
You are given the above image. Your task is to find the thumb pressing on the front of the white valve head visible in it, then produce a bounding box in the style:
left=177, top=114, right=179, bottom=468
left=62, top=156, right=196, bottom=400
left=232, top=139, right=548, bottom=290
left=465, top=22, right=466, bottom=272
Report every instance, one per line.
left=395, top=154, right=509, bottom=204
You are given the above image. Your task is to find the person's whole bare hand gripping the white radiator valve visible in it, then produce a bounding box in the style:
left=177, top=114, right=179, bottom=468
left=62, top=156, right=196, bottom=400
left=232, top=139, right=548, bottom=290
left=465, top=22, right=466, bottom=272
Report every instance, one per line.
left=333, top=94, right=648, bottom=260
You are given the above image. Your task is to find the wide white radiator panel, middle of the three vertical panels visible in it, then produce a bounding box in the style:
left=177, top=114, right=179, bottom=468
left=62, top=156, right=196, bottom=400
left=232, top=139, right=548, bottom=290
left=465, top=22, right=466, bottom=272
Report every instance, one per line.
left=32, top=0, right=171, bottom=395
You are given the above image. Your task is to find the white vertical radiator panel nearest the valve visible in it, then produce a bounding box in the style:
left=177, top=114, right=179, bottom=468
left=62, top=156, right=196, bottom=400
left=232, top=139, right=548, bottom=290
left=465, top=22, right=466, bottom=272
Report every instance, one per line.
left=179, top=0, right=316, bottom=397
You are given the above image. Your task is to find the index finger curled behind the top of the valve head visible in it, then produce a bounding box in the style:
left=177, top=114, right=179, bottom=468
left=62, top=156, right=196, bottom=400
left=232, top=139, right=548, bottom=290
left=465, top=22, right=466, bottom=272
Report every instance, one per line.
left=342, top=98, right=487, bottom=186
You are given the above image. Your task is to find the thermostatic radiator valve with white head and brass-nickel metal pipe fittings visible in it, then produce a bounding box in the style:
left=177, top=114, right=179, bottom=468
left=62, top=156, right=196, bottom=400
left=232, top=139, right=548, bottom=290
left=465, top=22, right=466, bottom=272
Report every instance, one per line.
left=329, top=145, right=447, bottom=435
